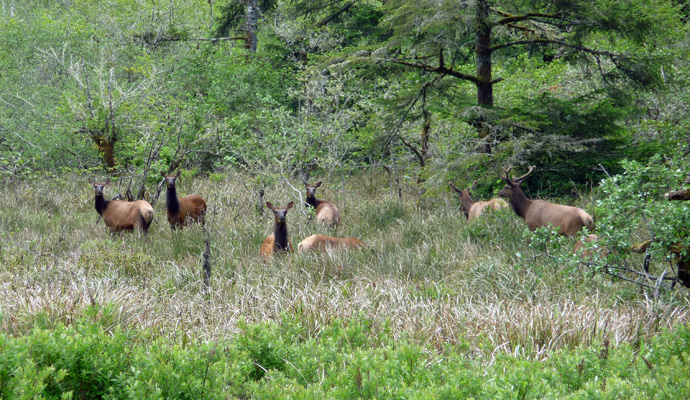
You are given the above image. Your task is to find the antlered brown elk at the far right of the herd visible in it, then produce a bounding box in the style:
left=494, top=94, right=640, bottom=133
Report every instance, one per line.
left=498, top=166, right=594, bottom=237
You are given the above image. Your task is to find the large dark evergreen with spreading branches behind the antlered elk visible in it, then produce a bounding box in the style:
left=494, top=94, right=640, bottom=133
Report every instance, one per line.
left=342, top=0, right=681, bottom=188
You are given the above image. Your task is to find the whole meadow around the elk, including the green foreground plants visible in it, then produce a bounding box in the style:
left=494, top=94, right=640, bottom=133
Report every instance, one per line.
left=0, top=172, right=690, bottom=398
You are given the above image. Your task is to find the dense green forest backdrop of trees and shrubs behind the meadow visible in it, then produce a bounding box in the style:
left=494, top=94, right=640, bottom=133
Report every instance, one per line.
left=0, top=0, right=689, bottom=193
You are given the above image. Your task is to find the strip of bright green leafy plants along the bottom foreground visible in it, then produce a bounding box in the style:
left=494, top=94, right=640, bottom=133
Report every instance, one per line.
left=0, top=317, right=690, bottom=399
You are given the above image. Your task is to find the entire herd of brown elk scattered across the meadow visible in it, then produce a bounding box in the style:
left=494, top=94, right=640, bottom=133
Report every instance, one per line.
left=89, top=166, right=596, bottom=259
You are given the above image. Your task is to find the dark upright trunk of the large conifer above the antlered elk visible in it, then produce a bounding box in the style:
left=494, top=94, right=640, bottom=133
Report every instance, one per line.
left=474, top=0, right=494, bottom=107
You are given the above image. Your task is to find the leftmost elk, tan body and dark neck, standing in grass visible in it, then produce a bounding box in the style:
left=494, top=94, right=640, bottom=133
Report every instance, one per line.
left=89, top=179, right=153, bottom=235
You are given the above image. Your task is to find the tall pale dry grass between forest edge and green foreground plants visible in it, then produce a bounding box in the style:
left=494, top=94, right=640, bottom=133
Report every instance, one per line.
left=0, top=172, right=689, bottom=360
